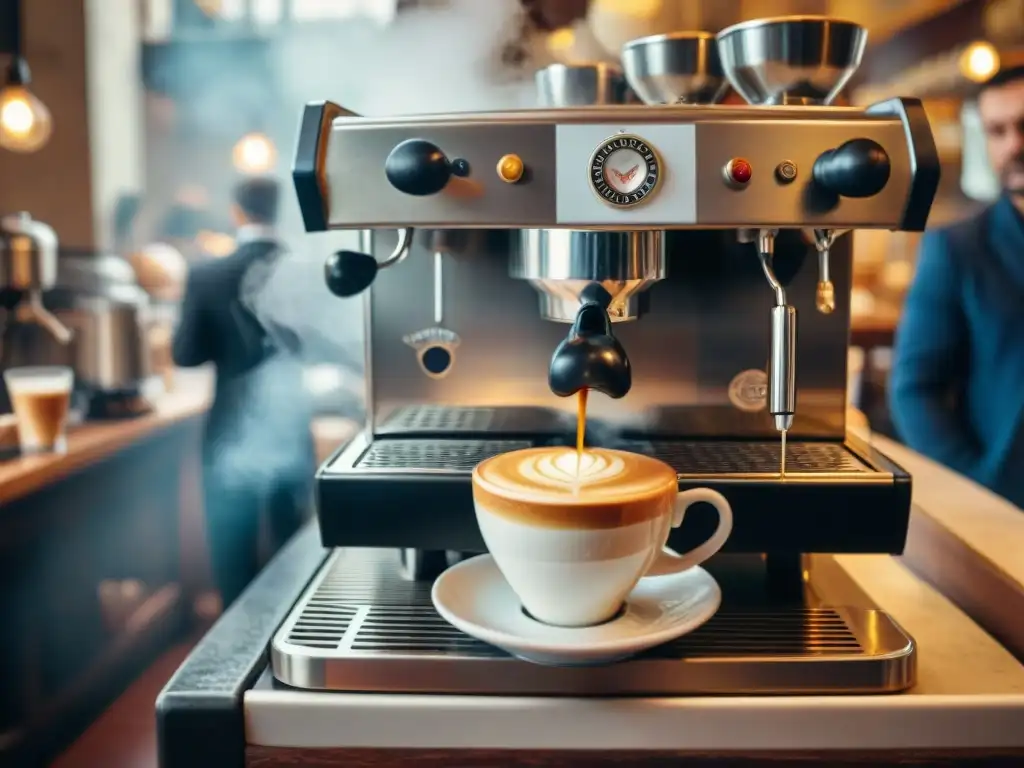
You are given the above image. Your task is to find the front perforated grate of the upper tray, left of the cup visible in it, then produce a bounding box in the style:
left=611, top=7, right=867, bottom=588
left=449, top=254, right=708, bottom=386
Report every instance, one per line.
left=355, top=439, right=531, bottom=472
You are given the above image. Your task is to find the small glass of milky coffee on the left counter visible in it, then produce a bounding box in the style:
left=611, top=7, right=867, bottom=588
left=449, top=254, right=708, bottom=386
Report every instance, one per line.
left=3, top=366, right=75, bottom=454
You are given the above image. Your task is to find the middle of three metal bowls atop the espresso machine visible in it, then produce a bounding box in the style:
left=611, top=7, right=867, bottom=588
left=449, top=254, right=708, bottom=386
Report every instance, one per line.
left=623, top=32, right=729, bottom=104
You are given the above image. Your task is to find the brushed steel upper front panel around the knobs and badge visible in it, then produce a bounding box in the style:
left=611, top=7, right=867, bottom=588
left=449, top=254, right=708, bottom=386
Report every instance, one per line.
left=326, top=105, right=910, bottom=229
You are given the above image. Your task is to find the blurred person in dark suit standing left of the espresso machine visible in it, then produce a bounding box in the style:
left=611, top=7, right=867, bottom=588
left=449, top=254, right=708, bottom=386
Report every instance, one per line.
left=172, top=178, right=315, bottom=608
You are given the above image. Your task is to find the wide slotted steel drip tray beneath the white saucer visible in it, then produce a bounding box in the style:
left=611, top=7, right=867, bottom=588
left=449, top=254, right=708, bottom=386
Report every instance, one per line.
left=270, top=549, right=915, bottom=696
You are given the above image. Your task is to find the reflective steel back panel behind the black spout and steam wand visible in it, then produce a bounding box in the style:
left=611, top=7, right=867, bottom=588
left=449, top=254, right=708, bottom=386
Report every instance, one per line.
left=367, top=230, right=851, bottom=440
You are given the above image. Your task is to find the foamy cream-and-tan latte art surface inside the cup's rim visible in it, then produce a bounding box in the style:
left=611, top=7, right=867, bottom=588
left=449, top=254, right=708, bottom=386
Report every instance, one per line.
left=473, top=447, right=676, bottom=505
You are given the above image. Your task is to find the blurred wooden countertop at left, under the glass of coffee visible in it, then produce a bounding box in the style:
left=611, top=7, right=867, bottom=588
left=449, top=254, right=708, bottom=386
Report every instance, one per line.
left=0, top=389, right=210, bottom=507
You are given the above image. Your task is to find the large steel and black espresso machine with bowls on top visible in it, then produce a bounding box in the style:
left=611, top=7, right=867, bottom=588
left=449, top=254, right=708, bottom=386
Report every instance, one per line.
left=271, top=16, right=939, bottom=695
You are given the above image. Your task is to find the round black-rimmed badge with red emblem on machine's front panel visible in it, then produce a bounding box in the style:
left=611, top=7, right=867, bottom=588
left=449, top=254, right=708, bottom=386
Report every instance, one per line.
left=590, top=133, right=662, bottom=208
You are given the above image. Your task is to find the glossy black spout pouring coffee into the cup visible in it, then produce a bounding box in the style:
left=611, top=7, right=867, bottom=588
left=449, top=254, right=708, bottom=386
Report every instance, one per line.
left=548, top=283, right=633, bottom=399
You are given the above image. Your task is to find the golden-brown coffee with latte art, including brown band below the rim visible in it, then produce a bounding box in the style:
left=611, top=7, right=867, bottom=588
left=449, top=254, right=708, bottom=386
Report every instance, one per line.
left=473, top=447, right=679, bottom=529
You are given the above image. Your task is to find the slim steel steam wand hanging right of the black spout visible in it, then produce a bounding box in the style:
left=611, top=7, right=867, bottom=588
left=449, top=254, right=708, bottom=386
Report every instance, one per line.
left=757, top=229, right=797, bottom=434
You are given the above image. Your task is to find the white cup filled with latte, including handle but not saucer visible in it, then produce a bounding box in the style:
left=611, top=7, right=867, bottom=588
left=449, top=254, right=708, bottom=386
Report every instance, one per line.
left=473, top=447, right=732, bottom=627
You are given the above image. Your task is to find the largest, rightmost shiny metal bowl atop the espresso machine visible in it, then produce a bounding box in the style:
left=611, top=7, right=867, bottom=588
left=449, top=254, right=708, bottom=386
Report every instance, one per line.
left=718, top=16, right=867, bottom=104
